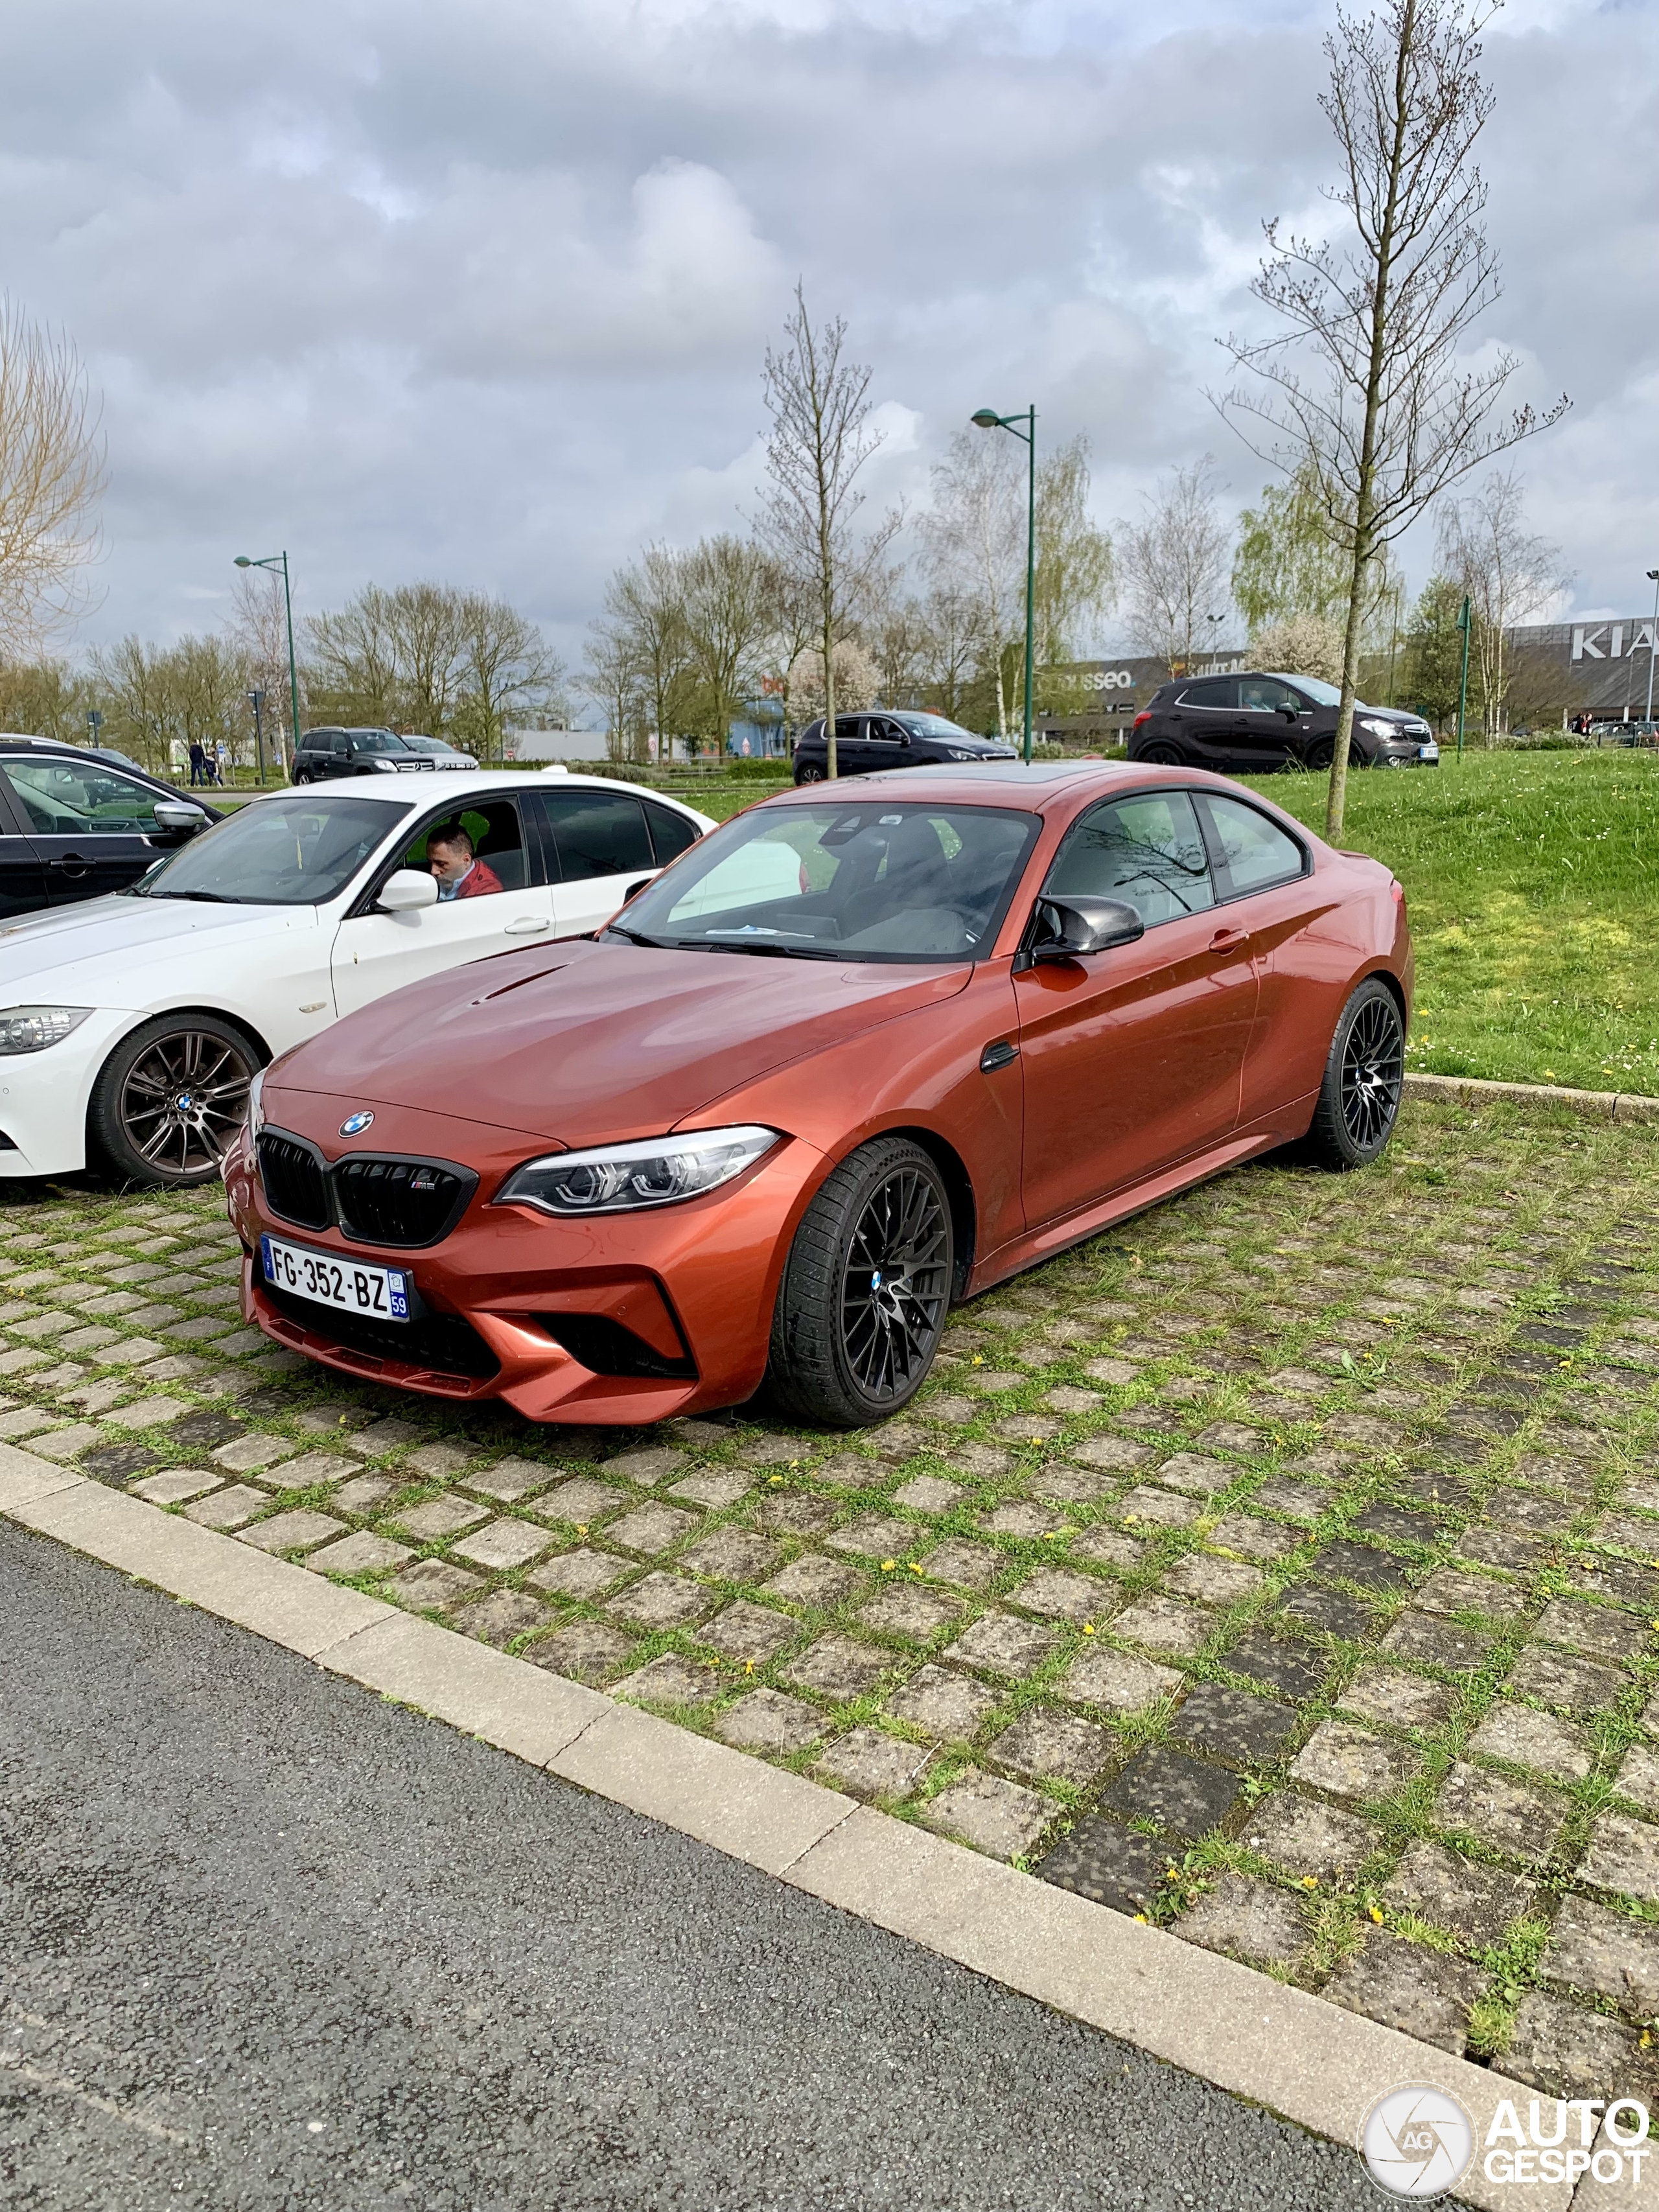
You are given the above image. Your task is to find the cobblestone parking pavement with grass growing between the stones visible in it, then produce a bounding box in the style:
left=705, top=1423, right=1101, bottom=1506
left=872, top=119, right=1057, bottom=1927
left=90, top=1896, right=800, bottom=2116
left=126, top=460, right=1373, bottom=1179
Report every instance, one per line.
left=0, top=1104, right=1659, bottom=2097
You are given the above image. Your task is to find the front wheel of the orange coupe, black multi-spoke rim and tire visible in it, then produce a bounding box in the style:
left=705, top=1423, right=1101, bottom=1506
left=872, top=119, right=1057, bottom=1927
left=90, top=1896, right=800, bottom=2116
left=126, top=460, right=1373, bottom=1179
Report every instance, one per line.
left=765, top=1137, right=956, bottom=1429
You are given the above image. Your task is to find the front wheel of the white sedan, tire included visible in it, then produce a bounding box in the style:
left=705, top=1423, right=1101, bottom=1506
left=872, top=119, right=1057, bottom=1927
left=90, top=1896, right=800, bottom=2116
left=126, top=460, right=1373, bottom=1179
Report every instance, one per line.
left=86, top=1013, right=263, bottom=1190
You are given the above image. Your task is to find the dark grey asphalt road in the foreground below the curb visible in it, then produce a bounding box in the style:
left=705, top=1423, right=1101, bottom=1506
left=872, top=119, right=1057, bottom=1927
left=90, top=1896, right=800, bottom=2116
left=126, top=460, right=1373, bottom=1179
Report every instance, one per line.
left=0, top=1528, right=1376, bottom=2212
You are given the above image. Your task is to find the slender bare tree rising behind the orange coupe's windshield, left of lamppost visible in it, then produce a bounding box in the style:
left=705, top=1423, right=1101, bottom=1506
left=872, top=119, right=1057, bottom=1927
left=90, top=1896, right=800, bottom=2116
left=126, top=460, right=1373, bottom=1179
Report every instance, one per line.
left=761, top=285, right=903, bottom=778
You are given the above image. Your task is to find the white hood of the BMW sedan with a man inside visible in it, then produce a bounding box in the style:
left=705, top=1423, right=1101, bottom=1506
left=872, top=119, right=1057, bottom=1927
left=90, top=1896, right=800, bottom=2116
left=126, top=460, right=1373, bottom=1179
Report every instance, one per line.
left=0, top=896, right=319, bottom=1007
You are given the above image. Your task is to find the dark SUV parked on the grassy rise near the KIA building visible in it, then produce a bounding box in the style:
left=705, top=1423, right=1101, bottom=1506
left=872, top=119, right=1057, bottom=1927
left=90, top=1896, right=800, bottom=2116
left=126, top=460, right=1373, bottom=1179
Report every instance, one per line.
left=1128, top=675, right=1440, bottom=776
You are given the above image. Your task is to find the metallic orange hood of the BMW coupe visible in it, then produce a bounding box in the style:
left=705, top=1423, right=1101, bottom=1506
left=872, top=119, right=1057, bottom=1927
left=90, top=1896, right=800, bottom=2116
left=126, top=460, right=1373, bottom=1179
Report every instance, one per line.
left=266, top=938, right=973, bottom=1146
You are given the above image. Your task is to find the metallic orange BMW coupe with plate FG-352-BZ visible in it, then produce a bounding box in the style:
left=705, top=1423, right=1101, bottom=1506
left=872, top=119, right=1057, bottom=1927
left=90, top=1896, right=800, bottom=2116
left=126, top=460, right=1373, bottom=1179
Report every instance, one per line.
left=226, top=763, right=1411, bottom=1426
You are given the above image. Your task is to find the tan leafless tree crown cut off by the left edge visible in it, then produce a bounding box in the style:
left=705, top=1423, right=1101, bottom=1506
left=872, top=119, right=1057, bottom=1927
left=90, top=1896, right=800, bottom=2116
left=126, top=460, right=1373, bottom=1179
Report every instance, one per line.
left=0, top=299, right=104, bottom=657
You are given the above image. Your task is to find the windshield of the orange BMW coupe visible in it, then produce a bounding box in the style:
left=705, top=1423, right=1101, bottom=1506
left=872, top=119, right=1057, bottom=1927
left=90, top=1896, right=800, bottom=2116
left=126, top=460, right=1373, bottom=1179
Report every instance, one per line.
left=617, top=798, right=1038, bottom=960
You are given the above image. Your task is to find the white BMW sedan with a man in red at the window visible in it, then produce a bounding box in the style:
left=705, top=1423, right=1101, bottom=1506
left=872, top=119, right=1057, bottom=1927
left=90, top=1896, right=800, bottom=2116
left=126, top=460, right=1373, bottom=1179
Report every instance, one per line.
left=0, top=770, right=715, bottom=1183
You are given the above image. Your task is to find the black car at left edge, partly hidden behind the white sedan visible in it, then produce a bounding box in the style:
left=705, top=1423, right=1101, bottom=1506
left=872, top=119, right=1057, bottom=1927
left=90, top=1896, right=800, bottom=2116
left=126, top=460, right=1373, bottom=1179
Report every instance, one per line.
left=0, top=737, right=224, bottom=920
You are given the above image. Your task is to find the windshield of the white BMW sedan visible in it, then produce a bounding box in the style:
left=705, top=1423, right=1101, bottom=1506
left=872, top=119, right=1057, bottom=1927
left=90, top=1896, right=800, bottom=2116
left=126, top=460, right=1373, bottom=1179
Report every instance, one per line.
left=124, top=792, right=412, bottom=907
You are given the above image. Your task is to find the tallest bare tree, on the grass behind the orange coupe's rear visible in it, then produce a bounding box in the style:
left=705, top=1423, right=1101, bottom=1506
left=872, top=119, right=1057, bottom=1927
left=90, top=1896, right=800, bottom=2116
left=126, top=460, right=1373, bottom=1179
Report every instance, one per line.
left=1219, top=0, right=1568, bottom=839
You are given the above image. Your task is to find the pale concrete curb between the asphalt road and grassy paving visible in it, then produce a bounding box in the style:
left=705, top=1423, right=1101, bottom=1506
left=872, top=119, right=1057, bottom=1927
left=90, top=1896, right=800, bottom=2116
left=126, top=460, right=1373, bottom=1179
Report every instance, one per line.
left=0, top=1445, right=1570, bottom=2212
